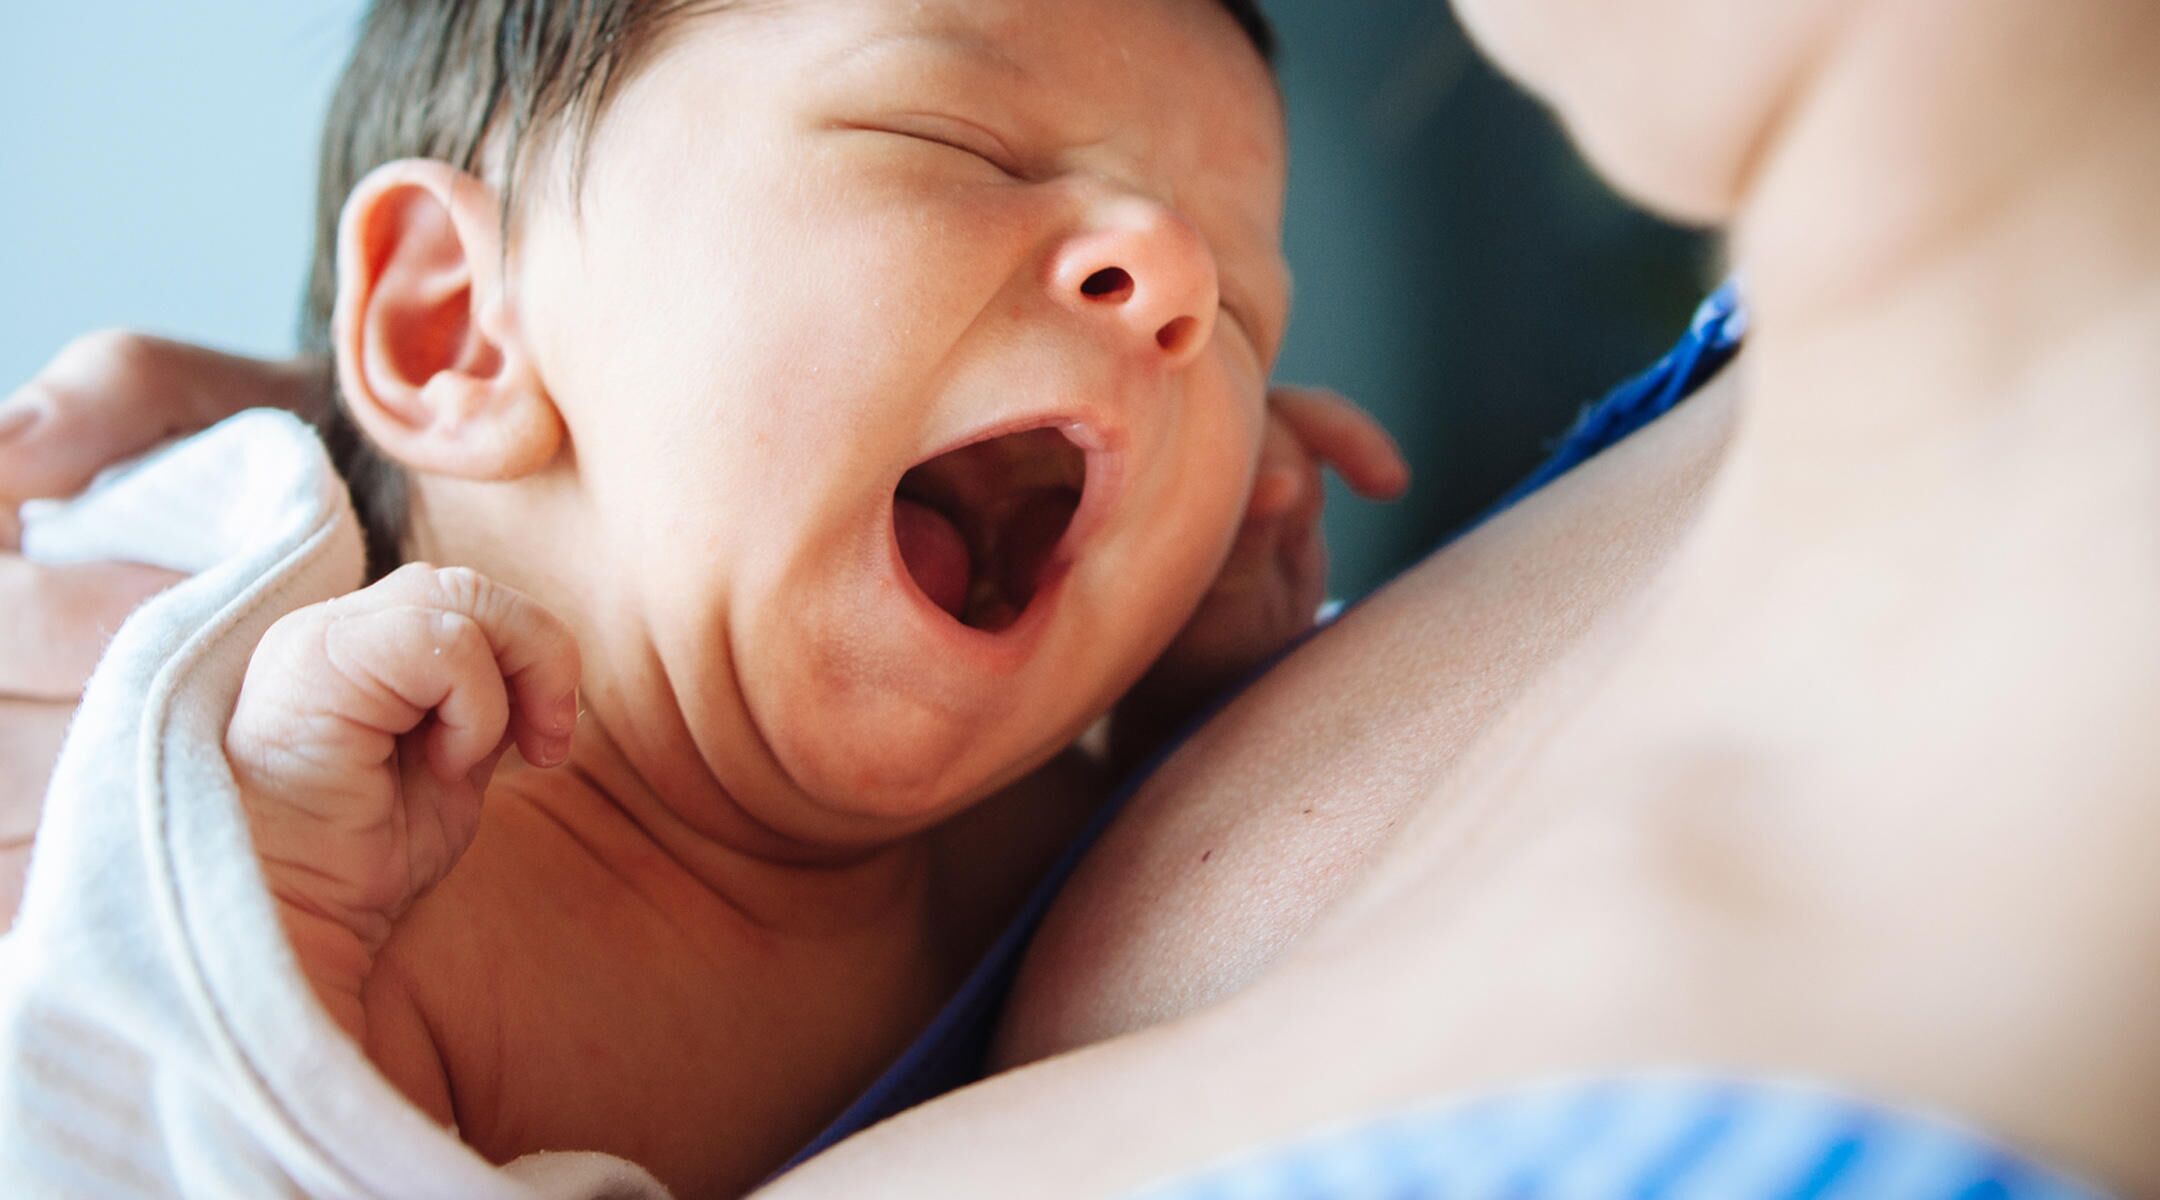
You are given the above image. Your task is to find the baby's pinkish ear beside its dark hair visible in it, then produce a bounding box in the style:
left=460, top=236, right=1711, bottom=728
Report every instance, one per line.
left=330, top=160, right=564, bottom=479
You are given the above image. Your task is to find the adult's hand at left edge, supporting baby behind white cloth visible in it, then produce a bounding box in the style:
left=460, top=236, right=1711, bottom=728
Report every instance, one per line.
left=0, top=332, right=320, bottom=928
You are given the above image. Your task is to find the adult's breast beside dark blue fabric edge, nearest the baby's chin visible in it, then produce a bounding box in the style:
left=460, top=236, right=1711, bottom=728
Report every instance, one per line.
left=998, top=384, right=1732, bottom=1064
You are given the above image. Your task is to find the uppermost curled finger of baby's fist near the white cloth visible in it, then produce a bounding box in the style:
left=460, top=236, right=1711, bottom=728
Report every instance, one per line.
left=346, top=563, right=579, bottom=768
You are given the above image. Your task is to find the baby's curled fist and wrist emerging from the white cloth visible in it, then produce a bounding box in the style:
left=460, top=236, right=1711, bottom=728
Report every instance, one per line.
left=225, top=565, right=579, bottom=1038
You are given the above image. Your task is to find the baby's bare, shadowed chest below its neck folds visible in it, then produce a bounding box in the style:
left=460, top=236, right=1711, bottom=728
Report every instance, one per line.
left=367, top=729, right=963, bottom=1196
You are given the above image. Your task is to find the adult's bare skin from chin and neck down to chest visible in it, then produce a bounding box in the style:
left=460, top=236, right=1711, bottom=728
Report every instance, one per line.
left=4, top=0, right=2160, bottom=1196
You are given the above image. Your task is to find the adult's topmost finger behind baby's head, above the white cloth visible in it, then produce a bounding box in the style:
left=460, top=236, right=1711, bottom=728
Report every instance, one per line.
left=0, top=332, right=324, bottom=503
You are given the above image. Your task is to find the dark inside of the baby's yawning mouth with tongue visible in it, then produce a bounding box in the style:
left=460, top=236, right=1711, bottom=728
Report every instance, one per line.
left=892, top=429, right=1086, bottom=632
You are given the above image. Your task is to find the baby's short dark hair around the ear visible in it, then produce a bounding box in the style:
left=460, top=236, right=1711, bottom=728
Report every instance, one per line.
left=300, top=0, right=1274, bottom=576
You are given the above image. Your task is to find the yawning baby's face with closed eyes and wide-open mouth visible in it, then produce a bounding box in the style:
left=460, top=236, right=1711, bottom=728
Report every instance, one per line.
left=514, top=0, right=1287, bottom=835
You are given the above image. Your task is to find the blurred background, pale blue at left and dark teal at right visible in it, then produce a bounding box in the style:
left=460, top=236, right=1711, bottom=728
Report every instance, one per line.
left=0, top=0, right=1713, bottom=596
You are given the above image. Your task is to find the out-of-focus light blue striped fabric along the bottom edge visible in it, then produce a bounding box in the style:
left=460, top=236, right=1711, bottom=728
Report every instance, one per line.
left=1138, top=1075, right=2104, bottom=1200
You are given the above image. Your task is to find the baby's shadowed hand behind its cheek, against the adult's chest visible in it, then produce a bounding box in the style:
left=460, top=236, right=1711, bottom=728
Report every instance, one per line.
left=1112, top=386, right=1410, bottom=764
